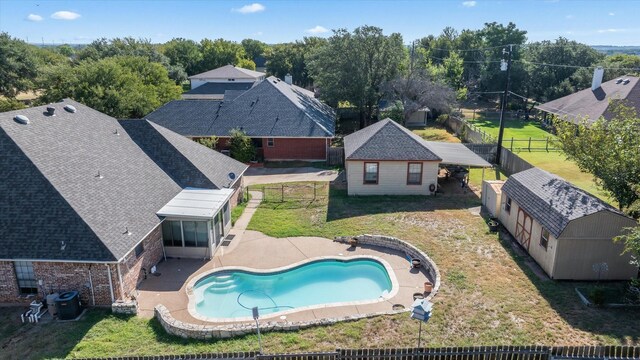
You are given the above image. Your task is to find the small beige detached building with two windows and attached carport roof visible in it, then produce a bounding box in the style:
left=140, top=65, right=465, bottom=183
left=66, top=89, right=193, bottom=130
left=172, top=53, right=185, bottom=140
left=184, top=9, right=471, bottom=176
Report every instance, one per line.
left=344, top=118, right=491, bottom=195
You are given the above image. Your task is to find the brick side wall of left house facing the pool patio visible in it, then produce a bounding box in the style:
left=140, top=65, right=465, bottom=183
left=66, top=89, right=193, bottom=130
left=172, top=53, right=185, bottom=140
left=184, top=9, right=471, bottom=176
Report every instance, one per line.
left=115, top=225, right=163, bottom=299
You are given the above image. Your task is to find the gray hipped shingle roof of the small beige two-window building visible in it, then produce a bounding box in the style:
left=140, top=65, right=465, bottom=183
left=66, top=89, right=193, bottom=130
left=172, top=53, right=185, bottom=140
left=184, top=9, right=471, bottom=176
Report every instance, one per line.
left=344, top=118, right=442, bottom=161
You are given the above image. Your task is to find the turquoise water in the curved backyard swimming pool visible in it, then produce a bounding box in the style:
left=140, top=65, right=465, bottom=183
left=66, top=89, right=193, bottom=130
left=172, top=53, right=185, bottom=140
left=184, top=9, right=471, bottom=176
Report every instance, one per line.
left=193, top=259, right=392, bottom=318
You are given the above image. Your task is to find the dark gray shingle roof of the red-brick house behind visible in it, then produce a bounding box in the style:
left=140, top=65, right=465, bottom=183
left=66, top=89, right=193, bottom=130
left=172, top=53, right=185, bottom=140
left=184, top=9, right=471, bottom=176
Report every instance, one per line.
left=146, top=76, right=335, bottom=137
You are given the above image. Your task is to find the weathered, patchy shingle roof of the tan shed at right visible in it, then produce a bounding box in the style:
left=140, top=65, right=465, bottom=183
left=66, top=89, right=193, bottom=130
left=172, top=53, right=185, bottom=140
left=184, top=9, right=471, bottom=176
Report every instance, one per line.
left=502, top=168, right=622, bottom=238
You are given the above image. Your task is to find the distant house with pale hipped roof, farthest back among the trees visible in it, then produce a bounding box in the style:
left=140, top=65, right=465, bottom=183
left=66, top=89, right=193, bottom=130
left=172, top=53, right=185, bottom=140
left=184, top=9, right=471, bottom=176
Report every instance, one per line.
left=182, top=65, right=265, bottom=100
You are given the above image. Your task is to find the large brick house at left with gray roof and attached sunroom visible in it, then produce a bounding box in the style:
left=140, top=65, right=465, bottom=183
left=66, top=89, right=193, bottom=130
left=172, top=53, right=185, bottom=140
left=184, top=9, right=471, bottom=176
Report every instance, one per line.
left=0, top=100, right=247, bottom=305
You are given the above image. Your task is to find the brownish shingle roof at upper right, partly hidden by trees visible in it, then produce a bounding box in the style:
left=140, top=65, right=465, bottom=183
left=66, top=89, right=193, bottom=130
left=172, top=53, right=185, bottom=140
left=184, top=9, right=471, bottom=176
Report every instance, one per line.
left=536, top=76, right=640, bottom=123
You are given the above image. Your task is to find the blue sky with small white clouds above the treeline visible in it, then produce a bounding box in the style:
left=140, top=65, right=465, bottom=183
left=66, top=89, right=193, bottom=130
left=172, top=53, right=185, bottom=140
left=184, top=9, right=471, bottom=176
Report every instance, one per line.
left=0, top=0, right=640, bottom=45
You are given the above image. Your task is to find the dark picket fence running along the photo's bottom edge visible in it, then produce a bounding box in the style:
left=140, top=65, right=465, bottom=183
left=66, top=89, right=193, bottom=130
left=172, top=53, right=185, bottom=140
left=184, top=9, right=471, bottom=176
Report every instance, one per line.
left=76, top=346, right=640, bottom=360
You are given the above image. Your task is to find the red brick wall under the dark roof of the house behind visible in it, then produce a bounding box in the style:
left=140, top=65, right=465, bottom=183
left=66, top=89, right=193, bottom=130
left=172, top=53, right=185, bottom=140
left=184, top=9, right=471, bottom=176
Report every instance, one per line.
left=262, top=138, right=330, bottom=161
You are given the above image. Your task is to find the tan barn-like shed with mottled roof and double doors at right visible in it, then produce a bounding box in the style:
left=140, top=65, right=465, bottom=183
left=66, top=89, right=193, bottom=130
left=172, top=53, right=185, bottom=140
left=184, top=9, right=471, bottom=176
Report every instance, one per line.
left=482, top=168, right=638, bottom=280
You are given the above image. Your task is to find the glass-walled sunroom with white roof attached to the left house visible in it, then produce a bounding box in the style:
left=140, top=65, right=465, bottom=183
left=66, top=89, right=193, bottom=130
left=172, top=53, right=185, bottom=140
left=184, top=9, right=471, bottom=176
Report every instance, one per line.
left=157, top=188, right=234, bottom=259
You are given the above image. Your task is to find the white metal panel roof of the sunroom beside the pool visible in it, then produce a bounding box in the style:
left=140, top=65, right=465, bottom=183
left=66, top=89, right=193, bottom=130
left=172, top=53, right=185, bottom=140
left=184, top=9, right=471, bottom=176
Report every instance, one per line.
left=157, top=188, right=233, bottom=219
